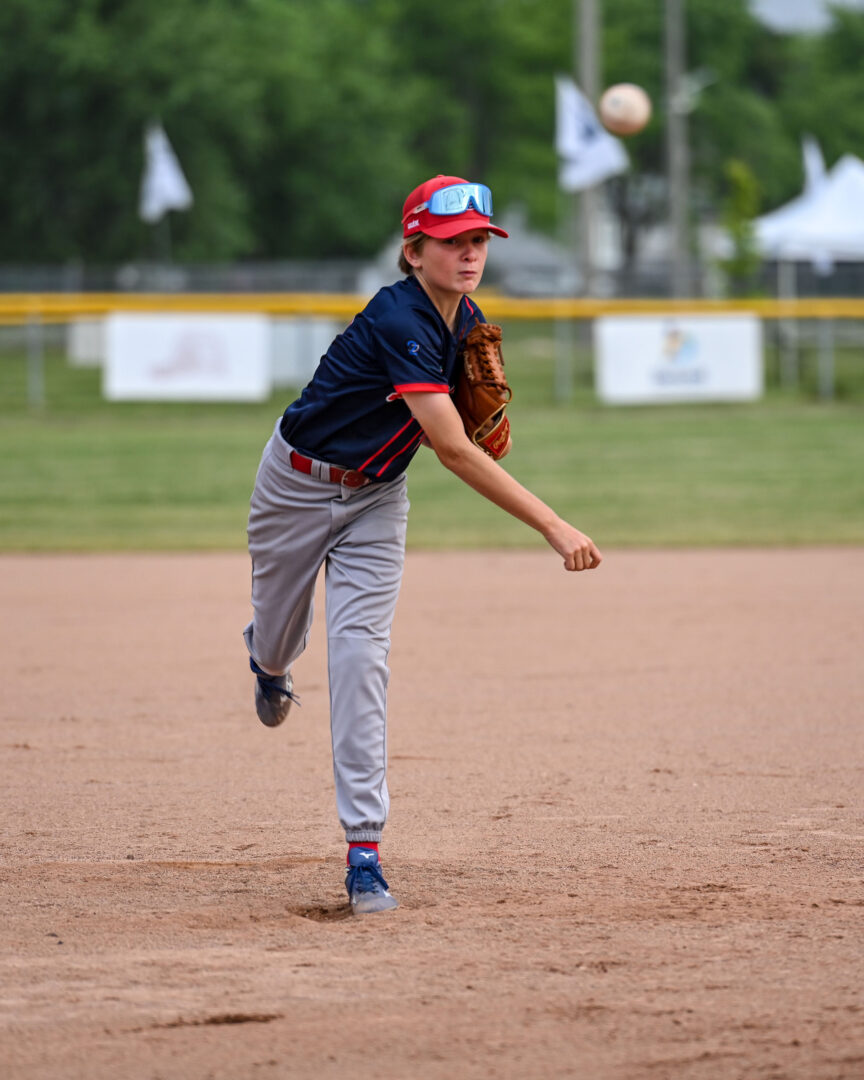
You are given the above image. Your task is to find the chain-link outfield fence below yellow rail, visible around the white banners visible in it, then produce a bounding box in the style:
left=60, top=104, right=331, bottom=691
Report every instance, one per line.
left=0, top=312, right=864, bottom=414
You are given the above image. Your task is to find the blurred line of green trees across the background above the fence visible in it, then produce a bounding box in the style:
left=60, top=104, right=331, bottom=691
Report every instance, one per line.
left=0, top=0, right=864, bottom=262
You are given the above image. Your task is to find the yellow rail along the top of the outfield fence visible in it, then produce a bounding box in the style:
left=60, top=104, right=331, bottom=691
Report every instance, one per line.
left=0, top=293, right=864, bottom=326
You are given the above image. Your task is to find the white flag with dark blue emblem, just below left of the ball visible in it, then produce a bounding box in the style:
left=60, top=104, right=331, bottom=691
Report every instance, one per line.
left=555, top=76, right=630, bottom=191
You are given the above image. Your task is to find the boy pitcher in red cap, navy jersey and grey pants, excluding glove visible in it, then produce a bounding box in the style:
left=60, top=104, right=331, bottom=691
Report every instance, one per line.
left=244, top=176, right=602, bottom=914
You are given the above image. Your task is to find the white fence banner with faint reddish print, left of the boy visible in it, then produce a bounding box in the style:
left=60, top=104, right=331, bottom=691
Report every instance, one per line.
left=103, top=313, right=271, bottom=402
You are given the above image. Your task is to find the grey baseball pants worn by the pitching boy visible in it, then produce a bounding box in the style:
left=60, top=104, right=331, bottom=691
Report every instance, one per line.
left=243, top=418, right=408, bottom=841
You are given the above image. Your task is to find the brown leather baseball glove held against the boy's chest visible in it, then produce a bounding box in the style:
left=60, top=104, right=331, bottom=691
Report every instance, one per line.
left=454, top=323, right=513, bottom=461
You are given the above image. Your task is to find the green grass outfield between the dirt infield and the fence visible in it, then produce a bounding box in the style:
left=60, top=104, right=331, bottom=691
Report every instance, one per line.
left=0, top=324, right=864, bottom=551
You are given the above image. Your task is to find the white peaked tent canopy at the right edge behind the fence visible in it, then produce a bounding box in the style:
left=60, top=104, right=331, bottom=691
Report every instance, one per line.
left=754, top=153, right=864, bottom=262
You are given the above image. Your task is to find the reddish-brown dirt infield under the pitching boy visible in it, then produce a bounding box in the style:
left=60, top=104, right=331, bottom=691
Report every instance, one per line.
left=0, top=550, right=864, bottom=1080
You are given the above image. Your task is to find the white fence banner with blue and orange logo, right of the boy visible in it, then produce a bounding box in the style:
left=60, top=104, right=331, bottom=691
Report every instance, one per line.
left=594, top=314, right=765, bottom=405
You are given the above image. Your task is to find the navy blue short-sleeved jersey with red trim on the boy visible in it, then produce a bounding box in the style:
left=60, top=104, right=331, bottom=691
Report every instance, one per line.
left=281, top=276, right=485, bottom=481
